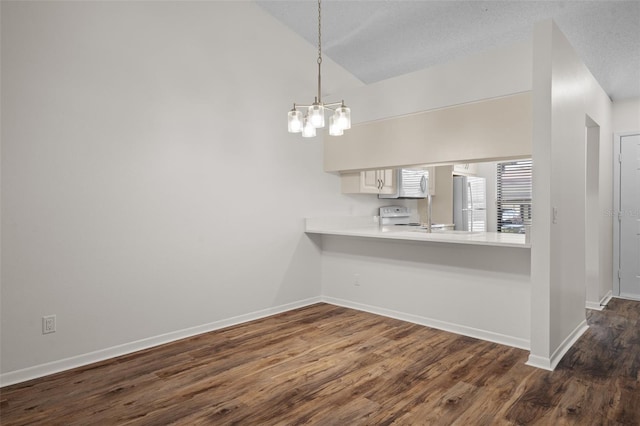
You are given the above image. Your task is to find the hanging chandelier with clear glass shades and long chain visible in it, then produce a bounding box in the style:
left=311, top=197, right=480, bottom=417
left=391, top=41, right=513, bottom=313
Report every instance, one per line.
left=288, top=0, right=351, bottom=138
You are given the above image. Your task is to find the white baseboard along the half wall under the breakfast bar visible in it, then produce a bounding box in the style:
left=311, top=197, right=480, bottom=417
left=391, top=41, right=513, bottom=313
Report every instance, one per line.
left=322, top=296, right=530, bottom=350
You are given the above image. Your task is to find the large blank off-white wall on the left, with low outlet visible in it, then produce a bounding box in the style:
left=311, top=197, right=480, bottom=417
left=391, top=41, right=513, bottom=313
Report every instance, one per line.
left=0, top=2, right=388, bottom=384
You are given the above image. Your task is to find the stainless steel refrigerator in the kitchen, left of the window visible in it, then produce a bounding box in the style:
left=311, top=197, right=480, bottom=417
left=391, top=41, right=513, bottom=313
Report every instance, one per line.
left=453, top=176, right=487, bottom=232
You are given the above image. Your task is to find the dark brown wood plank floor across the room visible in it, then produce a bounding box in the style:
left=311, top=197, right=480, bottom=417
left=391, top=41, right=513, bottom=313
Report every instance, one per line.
left=0, top=299, right=640, bottom=426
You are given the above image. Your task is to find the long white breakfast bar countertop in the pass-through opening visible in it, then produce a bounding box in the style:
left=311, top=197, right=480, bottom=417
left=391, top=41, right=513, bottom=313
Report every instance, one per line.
left=305, top=216, right=531, bottom=248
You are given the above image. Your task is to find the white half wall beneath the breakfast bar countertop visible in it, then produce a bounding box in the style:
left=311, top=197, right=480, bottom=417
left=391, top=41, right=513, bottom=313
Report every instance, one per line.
left=322, top=235, right=531, bottom=348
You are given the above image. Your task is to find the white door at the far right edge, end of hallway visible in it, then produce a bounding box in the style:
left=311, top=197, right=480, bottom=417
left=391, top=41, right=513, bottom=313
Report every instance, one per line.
left=613, top=132, right=640, bottom=300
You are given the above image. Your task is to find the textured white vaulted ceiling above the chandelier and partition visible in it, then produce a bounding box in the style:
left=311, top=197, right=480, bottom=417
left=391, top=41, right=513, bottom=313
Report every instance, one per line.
left=257, top=0, right=640, bottom=100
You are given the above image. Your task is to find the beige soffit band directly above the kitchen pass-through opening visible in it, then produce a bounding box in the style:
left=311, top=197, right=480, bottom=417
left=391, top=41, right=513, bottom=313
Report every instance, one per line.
left=324, top=92, right=532, bottom=172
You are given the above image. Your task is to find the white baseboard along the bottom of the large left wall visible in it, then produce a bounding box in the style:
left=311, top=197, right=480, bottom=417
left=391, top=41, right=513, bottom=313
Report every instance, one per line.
left=0, top=297, right=322, bottom=386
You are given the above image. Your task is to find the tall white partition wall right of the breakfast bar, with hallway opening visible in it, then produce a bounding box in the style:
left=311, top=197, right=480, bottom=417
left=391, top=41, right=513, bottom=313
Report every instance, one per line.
left=529, top=21, right=612, bottom=368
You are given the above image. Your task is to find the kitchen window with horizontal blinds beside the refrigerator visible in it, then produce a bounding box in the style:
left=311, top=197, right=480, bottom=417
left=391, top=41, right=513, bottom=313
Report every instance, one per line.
left=496, top=160, right=532, bottom=234
